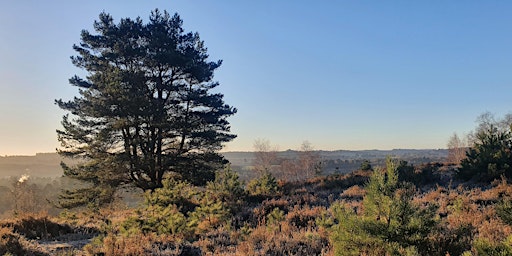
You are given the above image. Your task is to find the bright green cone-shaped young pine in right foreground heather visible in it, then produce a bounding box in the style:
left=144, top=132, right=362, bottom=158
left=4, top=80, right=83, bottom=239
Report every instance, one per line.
left=331, top=159, right=437, bottom=255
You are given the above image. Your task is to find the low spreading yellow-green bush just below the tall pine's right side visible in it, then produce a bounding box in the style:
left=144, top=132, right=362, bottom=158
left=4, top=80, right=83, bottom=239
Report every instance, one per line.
left=120, top=175, right=232, bottom=240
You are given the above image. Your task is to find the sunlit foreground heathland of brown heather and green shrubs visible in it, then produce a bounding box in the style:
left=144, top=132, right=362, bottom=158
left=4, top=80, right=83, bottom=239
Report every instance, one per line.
left=0, top=161, right=512, bottom=255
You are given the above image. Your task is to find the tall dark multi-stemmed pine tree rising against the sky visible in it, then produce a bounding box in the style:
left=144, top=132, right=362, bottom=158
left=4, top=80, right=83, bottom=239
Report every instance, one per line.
left=56, top=9, right=236, bottom=207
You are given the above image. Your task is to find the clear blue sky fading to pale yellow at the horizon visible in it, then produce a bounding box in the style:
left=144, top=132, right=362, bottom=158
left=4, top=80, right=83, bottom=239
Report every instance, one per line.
left=0, top=0, right=512, bottom=155
